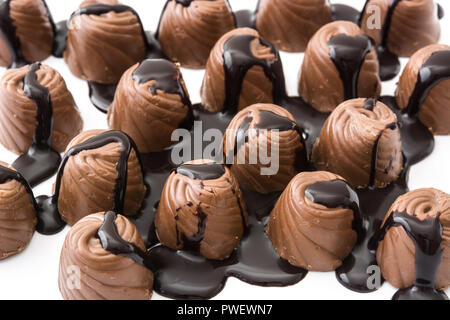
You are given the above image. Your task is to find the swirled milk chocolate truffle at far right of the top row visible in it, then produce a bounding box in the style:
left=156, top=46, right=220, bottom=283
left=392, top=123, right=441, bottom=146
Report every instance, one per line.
left=361, top=0, right=441, bottom=57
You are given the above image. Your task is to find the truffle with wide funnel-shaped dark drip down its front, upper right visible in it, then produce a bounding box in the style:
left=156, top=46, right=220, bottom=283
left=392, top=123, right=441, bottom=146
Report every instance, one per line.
left=299, top=21, right=381, bottom=112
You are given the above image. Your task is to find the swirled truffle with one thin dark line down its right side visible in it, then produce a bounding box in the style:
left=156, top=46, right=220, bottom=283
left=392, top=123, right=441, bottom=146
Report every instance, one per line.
left=312, top=99, right=403, bottom=188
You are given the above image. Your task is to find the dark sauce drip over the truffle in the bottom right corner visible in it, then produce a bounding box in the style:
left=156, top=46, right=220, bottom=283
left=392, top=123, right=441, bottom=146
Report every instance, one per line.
left=374, top=212, right=448, bottom=300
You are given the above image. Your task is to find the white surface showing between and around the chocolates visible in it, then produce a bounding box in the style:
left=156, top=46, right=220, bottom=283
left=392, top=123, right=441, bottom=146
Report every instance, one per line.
left=0, top=0, right=450, bottom=300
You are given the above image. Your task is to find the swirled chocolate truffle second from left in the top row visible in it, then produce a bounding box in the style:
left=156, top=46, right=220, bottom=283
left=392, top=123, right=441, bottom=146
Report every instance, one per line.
left=64, top=3, right=147, bottom=84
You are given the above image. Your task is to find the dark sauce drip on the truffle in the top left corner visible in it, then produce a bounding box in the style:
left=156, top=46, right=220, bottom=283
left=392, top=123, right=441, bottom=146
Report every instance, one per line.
left=0, top=0, right=29, bottom=68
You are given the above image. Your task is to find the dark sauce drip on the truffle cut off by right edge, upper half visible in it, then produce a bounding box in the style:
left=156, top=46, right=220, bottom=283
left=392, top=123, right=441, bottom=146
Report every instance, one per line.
left=406, top=50, right=450, bottom=116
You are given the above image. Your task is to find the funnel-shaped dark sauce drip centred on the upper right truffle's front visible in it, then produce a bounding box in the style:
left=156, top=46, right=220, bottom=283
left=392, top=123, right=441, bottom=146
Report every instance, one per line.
left=328, top=34, right=372, bottom=100
